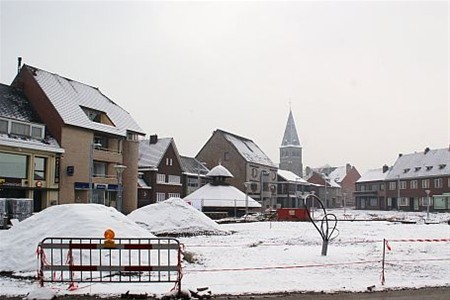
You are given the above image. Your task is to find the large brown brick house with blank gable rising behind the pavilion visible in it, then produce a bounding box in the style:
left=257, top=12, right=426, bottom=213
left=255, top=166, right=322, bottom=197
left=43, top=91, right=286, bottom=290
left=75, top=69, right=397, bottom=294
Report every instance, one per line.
left=195, top=129, right=278, bottom=208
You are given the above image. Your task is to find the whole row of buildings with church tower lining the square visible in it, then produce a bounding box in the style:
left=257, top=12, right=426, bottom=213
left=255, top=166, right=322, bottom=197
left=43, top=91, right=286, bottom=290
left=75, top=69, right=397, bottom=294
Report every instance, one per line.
left=0, top=65, right=450, bottom=213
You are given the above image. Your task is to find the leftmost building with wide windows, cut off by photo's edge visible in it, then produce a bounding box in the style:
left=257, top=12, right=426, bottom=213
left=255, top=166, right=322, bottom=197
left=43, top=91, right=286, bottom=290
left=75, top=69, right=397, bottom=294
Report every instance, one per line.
left=0, top=84, right=64, bottom=212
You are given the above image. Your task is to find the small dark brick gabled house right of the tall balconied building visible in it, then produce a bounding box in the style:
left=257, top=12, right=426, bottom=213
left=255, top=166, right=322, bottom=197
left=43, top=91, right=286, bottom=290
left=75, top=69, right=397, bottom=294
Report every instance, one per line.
left=138, top=135, right=183, bottom=207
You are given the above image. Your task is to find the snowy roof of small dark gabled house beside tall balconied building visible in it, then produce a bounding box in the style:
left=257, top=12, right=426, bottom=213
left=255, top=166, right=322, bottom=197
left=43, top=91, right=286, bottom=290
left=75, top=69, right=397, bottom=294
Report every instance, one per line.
left=138, top=138, right=173, bottom=168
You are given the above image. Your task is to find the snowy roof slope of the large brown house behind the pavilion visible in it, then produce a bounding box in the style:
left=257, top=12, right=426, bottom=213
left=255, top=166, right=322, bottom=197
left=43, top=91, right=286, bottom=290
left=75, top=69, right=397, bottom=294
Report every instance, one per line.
left=216, top=129, right=276, bottom=167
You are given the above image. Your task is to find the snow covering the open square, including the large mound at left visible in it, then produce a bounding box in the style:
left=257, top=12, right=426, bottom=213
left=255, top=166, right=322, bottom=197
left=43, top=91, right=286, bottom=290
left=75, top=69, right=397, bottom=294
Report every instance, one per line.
left=0, top=204, right=450, bottom=296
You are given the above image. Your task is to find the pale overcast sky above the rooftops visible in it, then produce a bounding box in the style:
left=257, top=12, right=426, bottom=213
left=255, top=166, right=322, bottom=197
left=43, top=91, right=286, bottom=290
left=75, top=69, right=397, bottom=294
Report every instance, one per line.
left=0, top=0, right=450, bottom=172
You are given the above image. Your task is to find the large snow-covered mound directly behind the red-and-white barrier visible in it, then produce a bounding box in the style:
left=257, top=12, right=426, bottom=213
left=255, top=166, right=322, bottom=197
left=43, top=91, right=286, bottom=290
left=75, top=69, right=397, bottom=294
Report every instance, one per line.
left=0, top=204, right=154, bottom=272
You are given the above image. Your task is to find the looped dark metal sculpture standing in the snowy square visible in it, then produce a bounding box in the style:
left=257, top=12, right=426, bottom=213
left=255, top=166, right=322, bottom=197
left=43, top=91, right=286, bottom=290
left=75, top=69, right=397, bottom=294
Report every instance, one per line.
left=303, top=193, right=339, bottom=256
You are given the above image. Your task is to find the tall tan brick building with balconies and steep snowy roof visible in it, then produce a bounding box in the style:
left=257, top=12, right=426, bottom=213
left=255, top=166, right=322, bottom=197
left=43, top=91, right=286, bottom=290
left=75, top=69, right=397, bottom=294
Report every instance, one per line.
left=11, top=65, right=144, bottom=213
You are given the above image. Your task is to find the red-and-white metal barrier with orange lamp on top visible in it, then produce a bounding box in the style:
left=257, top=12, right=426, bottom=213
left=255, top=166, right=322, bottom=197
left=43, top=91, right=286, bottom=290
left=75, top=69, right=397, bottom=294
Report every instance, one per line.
left=37, top=237, right=182, bottom=292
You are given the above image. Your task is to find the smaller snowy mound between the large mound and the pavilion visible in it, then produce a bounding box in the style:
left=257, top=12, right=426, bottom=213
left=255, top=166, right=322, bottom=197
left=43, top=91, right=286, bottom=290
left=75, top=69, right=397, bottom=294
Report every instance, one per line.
left=128, top=198, right=229, bottom=236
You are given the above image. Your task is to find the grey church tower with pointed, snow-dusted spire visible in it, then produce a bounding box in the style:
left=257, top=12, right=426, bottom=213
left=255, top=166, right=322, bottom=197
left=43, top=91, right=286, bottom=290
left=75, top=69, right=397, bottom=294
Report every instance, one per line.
left=280, top=109, right=303, bottom=177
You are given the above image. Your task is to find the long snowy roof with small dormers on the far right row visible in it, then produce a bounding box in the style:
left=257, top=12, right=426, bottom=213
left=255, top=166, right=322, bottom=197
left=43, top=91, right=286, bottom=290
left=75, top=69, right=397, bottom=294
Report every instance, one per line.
left=386, top=148, right=450, bottom=180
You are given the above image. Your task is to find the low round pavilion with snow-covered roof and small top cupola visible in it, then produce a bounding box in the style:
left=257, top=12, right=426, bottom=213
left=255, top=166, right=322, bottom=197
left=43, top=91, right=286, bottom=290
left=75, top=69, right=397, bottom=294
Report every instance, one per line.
left=184, top=165, right=261, bottom=219
